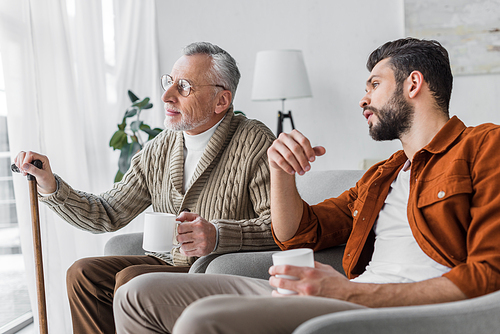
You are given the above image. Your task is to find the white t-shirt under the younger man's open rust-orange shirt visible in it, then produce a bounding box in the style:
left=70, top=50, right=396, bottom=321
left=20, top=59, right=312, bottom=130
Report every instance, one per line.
left=352, top=161, right=451, bottom=283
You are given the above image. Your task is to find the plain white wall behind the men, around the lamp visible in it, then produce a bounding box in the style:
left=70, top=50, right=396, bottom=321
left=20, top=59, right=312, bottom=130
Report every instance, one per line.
left=156, top=0, right=500, bottom=170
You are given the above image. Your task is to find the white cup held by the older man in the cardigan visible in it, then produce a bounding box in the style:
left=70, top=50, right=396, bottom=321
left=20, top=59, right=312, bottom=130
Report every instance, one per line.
left=142, top=212, right=180, bottom=252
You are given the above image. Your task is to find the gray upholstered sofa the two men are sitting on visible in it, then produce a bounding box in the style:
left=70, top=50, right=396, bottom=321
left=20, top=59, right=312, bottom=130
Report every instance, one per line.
left=104, top=170, right=500, bottom=334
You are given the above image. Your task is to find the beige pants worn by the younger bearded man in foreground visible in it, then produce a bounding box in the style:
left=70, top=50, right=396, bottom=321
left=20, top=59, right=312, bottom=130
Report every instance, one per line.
left=113, top=273, right=365, bottom=334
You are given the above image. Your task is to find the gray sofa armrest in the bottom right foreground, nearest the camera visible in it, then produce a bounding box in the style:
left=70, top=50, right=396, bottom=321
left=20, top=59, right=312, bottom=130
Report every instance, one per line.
left=293, top=291, right=500, bottom=334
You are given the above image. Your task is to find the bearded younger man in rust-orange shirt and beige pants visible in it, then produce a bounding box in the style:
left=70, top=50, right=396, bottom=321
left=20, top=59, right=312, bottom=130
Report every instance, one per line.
left=114, top=38, right=500, bottom=334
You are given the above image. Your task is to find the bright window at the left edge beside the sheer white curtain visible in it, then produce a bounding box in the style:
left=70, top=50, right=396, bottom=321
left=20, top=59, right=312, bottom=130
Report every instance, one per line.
left=0, top=54, right=33, bottom=333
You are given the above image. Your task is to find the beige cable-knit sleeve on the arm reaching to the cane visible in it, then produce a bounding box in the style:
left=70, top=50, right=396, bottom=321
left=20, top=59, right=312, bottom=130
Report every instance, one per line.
left=39, top=151, right=151, bottom=233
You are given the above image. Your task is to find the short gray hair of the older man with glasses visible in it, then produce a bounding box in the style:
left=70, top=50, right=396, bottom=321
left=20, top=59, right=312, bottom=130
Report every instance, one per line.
left=184, top=42, right=241, bottom=102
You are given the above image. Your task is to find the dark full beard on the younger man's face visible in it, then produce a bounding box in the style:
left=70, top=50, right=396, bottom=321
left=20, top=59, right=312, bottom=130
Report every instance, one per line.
left=364, top=85, right=415, bottom=141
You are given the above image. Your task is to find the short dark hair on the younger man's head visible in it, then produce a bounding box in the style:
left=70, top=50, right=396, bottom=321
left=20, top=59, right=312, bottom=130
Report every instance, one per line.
left=366, top=38, right=453, bottom=115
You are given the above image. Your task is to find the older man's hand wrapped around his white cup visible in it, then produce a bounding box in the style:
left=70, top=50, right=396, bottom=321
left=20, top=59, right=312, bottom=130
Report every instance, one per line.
left=177, top=212, right=217, bottom=256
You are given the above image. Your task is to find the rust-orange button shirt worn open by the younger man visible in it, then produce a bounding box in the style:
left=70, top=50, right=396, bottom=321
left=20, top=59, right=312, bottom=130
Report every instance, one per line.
left=276, top=117, right=500, bottom=298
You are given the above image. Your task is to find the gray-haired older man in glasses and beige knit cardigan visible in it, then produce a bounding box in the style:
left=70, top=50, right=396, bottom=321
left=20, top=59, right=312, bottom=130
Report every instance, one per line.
left=15, top=43, right=277, bottom=333
